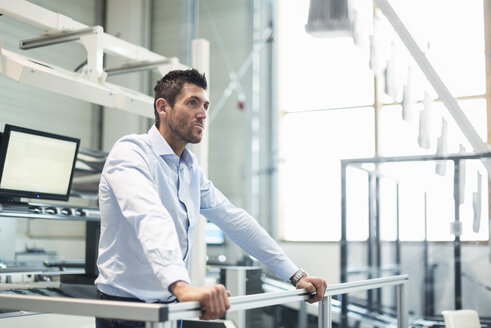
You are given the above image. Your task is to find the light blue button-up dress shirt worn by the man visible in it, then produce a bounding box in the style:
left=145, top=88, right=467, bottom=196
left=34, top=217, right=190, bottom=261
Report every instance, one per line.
left=95, top=125, right=297, bottom=302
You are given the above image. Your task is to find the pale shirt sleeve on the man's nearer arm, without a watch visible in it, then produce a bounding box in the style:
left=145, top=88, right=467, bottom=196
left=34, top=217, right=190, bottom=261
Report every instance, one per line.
left=100, top=140, right=190, bottom=289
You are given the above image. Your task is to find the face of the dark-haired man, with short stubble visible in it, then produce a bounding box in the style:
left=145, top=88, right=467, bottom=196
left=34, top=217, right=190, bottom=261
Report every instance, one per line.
left=167, top=83, right=210, bottom=143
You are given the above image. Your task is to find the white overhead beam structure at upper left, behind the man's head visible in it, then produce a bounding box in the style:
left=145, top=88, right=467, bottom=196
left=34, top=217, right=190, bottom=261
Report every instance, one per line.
left=0, top=0, right=194, bottom=118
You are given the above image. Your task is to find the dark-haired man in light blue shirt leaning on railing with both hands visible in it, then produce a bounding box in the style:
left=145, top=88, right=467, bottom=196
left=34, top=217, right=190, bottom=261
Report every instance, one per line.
left=96, top=69, right=326, bottom=327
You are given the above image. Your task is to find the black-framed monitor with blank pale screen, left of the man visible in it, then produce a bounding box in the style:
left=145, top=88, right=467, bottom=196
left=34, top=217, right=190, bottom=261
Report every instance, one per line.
left=0, top=124, right=80, bottom=200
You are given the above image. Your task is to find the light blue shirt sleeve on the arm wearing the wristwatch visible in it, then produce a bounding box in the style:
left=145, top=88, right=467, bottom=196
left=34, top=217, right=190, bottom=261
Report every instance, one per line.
left=200, top=168, right=298, bottom=281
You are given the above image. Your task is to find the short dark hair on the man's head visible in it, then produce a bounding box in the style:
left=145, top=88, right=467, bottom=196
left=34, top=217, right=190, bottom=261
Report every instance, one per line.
left=153, top=68, right=207, bottom=128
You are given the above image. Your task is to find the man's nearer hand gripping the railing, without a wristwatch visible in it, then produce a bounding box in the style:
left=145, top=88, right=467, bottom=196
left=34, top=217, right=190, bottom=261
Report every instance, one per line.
left=169, top=281, right=230, bottom=320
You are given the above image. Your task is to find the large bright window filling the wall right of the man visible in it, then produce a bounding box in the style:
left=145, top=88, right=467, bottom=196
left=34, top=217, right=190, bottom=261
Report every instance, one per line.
left=278, top=0, right=489, bottom=241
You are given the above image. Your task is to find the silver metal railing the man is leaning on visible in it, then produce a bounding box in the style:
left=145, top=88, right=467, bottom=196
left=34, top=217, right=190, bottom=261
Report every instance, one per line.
left=0, top=275, right=409, bottom=328
